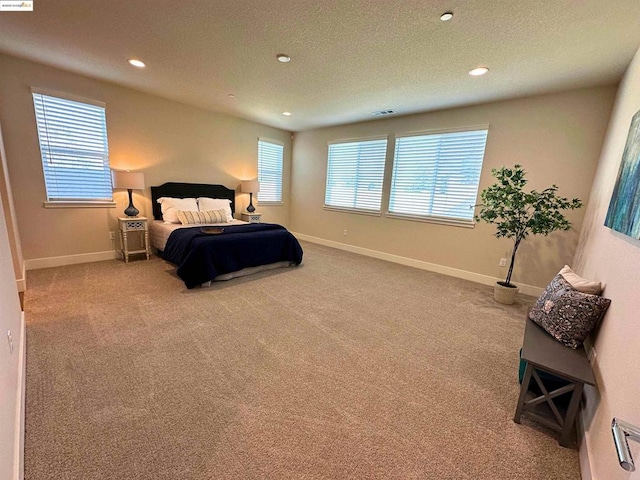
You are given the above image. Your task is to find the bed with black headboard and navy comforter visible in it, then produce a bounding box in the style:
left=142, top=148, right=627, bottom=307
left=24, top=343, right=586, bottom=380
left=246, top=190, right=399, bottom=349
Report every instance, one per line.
left=149, top=182, right=303, bottom=288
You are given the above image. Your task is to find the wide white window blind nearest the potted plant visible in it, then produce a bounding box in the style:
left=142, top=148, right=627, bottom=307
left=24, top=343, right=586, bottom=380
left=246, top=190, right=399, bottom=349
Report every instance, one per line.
left=389, top=130, right=488, bottom=222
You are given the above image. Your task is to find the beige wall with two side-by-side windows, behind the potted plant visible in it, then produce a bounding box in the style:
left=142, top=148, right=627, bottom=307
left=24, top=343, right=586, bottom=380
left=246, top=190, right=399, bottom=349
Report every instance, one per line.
left=291, top=86, right=616, bottom=287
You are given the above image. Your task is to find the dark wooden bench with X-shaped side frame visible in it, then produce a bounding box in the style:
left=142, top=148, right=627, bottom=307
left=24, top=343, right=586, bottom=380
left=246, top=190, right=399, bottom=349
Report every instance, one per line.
left=513, top=317, right=596, bottom=447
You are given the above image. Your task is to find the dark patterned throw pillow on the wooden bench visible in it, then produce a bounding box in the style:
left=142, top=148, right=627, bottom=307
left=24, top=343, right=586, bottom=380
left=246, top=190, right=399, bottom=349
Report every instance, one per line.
left=529, top=274, right=611, bottom=349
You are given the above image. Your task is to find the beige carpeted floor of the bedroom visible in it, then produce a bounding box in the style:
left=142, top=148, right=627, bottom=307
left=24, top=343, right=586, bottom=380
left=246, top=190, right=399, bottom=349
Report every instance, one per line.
left=25, top=243, right=580, bottom=480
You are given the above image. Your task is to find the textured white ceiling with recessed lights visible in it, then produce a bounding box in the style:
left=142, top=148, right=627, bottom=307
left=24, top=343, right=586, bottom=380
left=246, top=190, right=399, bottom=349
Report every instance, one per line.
left=0, top=0, right=640, bottom=131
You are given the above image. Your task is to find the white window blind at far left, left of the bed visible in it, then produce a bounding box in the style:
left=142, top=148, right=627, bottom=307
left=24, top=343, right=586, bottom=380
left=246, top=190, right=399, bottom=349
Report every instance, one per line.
left=33, top=93, right=113, bottom=202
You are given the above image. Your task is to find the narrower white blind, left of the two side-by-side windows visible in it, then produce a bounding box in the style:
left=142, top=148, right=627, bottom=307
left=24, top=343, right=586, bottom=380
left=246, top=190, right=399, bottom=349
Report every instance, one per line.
left=324, top=138, right=387, bottom=212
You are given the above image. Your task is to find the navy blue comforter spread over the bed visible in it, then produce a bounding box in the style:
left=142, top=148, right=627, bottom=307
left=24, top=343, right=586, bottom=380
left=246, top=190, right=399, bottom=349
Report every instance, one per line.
left=163, top=223, right=302, bottom=288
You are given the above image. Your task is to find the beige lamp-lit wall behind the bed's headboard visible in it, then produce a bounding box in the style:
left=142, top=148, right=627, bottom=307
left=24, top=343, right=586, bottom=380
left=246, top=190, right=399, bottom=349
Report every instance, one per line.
left=0, top=55, right=291, bottom=261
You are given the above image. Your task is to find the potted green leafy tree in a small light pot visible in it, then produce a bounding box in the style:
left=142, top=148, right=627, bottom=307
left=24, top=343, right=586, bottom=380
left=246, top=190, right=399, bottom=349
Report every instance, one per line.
left=475, top=165, right=582, bottom=305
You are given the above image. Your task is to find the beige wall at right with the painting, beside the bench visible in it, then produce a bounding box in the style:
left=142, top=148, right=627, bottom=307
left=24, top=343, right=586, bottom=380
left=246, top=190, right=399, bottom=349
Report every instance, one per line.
left=575, top=44, right=640, bottom=480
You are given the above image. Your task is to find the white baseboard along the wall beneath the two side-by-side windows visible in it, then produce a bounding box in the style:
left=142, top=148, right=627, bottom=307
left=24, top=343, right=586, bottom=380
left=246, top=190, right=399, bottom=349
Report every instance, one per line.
left=292, top=232, right=543, bottom=297
